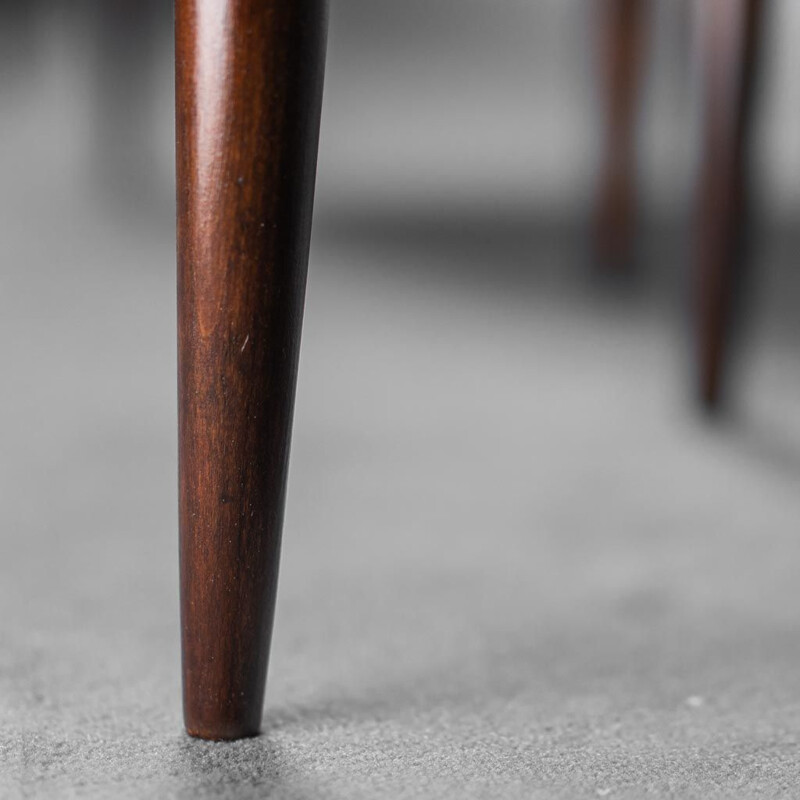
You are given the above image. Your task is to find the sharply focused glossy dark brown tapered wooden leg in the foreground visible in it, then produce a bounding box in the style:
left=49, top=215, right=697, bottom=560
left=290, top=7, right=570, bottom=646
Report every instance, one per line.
left=175, top=0, right=326, bottom=739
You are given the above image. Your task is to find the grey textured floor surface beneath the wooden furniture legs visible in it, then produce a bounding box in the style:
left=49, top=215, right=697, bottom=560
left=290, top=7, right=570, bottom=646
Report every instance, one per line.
left=0, top=189, right=800, bottom=798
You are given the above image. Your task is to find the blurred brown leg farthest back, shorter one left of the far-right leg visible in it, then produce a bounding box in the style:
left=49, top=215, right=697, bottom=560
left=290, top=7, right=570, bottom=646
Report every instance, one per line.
left=595, top=0, right=647, bottom=269
